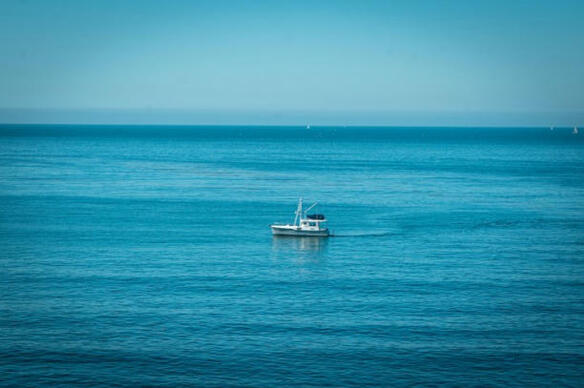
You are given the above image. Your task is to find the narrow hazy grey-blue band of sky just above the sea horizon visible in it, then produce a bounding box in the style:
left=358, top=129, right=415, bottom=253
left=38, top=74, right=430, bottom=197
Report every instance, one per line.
left=0, top=109, right=584, bottom=127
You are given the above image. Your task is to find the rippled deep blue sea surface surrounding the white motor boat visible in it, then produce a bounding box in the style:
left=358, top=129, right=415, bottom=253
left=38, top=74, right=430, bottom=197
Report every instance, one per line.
left=0, top=125, right=584, bottom=387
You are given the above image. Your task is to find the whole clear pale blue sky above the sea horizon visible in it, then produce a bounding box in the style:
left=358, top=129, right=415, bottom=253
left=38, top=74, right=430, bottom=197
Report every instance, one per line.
left=0, top=0, right=584, bottom=126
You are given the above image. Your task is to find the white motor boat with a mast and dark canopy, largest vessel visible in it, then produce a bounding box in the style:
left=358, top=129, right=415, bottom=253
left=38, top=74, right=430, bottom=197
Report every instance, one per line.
left=270, top=198, right=330, bottom=237
